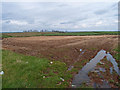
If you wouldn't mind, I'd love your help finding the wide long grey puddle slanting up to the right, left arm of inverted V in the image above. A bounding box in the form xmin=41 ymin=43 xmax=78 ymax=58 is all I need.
xmin=72 ymin=50 xmax=106 ymax=87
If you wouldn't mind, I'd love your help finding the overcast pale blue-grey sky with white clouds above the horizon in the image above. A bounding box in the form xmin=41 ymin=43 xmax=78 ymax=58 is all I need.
xmin=2 ymin=2 xmax=118 ymax=32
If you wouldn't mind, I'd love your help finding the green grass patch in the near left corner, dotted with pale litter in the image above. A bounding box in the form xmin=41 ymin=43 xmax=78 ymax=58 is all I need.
xmin=2 ymin=50 xmax=72 ymax=88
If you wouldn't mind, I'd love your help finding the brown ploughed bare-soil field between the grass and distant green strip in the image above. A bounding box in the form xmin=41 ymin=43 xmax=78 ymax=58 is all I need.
xmin=2 ymin=35 xmax=118 ymax=87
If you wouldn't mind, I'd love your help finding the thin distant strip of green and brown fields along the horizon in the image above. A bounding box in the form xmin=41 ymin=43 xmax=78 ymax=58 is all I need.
xmin=2 ymin=31 xmax=120 ymax=38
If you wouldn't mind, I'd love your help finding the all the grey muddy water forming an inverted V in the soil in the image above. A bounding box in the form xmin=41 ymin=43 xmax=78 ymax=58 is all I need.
xmin=72 ymin=50 xmax=120 ymax=88
